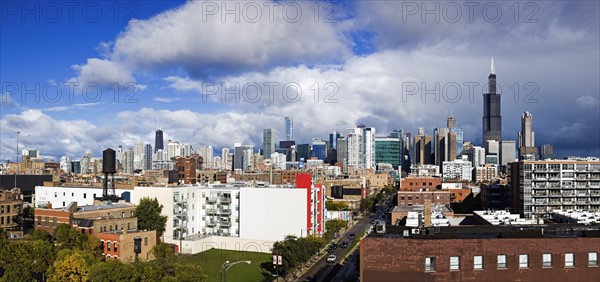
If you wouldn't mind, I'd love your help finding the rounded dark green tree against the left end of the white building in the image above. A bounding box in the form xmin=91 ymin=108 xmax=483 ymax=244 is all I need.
xmin=133 ymin=197 xmax=167 ymax=234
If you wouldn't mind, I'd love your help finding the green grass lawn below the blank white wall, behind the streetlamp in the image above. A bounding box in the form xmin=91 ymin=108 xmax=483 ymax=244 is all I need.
xmin=178 ymin=249 xmax=272 ymax=282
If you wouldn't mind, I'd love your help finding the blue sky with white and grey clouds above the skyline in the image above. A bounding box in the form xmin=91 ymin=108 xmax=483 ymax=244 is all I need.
xmin=0 ymin=1 xmax=600 ymax=160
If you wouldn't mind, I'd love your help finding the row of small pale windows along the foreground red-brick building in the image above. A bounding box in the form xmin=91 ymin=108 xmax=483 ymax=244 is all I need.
xmin=425 ymin=252 xmax=598 ymax=272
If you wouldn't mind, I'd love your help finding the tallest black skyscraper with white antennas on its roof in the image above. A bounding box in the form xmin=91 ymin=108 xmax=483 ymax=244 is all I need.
xmin=482 ymin=58 xmax=502 ymax=150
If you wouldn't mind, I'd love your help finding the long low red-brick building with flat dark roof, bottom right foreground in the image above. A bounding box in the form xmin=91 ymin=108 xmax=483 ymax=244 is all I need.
xmin=360 ymin=224 xmax=600 ymax=281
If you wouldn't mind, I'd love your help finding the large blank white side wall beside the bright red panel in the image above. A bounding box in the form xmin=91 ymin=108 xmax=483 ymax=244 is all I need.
xmin=240 ymin=188 xmax=308 ymax=241
